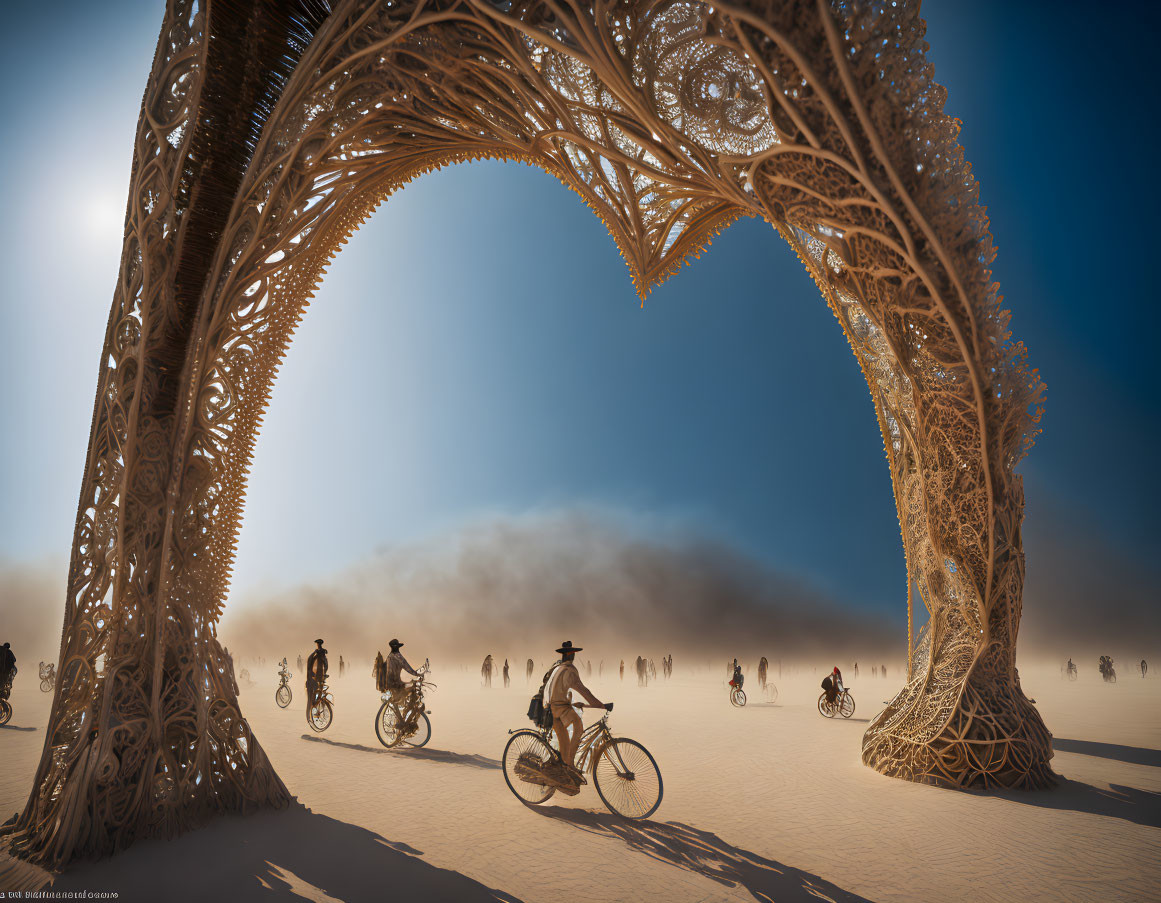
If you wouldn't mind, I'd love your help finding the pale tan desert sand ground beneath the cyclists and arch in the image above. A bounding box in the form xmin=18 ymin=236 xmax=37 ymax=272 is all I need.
xmin=0 ymin=656 xmax=1161 ymax=903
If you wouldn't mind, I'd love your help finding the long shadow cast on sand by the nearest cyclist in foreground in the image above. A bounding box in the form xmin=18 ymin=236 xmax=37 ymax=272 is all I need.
xmin=529 ymin=806 xmax=871 ymax=903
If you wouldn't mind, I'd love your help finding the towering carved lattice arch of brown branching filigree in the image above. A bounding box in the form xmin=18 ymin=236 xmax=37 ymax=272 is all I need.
xmin=7 ymin=0 xmax=1052 ymax=866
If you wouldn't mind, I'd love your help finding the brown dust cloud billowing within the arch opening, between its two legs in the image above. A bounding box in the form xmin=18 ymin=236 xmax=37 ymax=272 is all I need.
xmin=219 ymin=512 xmax=907 ymax=667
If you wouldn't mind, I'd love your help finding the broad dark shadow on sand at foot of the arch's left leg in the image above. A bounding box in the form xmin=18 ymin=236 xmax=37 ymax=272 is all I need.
xmin=37 ymin=803 xmax=519 ymax=903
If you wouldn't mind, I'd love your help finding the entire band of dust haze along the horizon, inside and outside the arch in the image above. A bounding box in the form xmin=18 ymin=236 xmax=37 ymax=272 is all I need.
xmin=0 ymin=510 xmax=1161 ymax=669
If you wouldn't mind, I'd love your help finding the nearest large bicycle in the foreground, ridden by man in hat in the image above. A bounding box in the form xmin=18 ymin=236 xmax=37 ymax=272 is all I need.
xmin=503 ymin=702 xmax=665 ymax=819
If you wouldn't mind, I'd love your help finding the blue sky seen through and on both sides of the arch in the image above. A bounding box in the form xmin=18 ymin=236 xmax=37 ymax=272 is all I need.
xmin=0 ymin=0 xmax=1161 ymax=620
